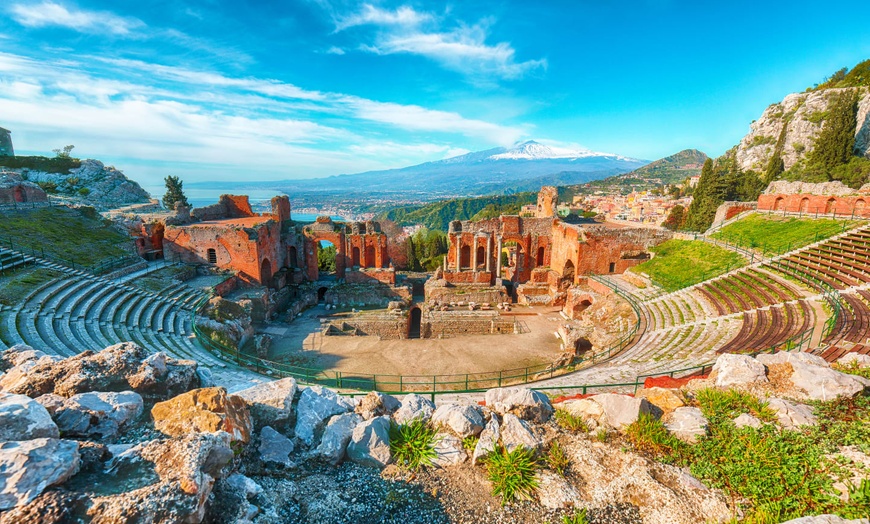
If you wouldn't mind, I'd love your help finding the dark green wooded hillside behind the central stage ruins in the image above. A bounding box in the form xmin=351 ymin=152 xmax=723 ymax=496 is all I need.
xmin=378 ymin=193 xmax=537 ymax=231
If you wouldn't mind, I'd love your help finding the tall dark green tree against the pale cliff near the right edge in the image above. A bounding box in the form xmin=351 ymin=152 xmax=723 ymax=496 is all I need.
xmin=808 ymin=90 xmax=858 ymax=173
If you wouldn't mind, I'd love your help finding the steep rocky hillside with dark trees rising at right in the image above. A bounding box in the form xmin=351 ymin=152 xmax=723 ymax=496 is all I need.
xmin=686 ymin=60 xmax=870 ymax=231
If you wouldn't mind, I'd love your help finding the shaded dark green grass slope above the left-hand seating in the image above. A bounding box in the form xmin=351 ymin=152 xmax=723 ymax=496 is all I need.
xmin=0 ymin=207 xmax=132 ymax=267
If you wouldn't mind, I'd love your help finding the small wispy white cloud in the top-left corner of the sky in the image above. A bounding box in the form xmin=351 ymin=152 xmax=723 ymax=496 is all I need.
xmin=9 ymin=0 xmax=145 ymax=36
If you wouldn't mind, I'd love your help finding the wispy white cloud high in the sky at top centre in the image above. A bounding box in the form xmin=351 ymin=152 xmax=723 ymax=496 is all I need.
xmin=335 ymin=4 xmax=547 ymax=79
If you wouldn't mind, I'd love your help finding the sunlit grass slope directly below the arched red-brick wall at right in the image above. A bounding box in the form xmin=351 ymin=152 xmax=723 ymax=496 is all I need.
xmin=711 ymin=214 xmax=861 ymax=255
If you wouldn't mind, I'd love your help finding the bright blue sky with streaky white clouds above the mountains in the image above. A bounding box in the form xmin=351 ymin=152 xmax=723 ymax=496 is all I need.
xmin=0 ymin=0 xmax=870 ymax=186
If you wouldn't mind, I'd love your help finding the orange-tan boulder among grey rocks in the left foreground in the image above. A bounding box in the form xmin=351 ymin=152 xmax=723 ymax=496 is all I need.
xmin=151 ymin=388 xmax=251 ymax=443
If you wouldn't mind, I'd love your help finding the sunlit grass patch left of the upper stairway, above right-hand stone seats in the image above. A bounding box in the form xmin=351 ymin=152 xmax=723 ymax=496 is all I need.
xmin=631 ymin=240 xmax=746 ymax=292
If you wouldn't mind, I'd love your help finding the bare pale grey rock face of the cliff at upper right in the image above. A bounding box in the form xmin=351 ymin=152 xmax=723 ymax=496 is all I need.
xmin=736 ymin=87 xmax=870 ymax=172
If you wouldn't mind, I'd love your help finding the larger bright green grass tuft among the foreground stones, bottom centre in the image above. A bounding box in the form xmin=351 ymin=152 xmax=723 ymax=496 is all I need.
xmin=486 ymin=446 xmax=538 ymax=504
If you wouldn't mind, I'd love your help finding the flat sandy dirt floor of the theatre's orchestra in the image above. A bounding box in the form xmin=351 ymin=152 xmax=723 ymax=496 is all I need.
xmin=262 ymin=306 xmax=562 ymax=375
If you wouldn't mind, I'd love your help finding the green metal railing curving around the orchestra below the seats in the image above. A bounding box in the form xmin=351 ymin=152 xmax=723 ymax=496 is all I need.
xmin=191 ymin=275 xmax=643 ymax=394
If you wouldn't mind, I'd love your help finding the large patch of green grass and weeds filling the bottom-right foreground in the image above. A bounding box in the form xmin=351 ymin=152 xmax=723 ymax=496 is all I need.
xmin=626 ymin=389 xmax=870 ymax=524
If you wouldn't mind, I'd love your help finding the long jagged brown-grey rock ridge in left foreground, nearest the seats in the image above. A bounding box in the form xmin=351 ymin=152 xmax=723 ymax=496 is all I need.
xmin=0 ymin=342 xmax=199 ymax=398
